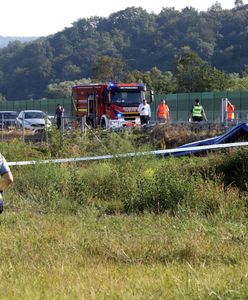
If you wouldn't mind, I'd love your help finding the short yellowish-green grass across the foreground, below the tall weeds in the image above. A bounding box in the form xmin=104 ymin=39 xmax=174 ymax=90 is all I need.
xmin=0 ymin=210 xmax=248 ymax=299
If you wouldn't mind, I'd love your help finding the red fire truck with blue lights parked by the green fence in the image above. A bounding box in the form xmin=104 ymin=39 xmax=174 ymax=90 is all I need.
xmin=72 ymin=82 xmax=153 ymax=128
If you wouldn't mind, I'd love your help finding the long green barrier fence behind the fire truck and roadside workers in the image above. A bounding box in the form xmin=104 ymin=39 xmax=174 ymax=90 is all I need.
xmin=0 ymin=91 xmax=248 ymax=122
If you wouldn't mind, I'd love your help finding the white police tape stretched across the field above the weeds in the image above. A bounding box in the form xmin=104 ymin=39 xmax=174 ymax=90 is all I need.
xmin=8 ymin=142 xmax=248 ymax=166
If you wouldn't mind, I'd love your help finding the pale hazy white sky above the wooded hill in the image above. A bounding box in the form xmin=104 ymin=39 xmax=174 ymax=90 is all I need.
xmin=0 ymin=0 xmax=243 ymax=36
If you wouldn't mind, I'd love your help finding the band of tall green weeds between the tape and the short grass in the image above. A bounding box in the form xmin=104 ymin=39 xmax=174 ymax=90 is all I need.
xmin=7 ymin=136 xmax=248 ymax=219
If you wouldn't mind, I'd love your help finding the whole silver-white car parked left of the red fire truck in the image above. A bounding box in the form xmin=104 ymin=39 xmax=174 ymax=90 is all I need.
xmin=16 ymin=110 xmax=51 ymax=131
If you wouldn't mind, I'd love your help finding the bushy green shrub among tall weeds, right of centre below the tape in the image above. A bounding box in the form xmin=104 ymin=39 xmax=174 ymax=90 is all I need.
xmin=124 ymin=158 xmax=192 ymax=213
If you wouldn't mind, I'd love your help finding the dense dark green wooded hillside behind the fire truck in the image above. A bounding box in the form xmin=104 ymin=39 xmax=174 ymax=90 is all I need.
xmin=0 ymin=1 xmax=248 ymax=100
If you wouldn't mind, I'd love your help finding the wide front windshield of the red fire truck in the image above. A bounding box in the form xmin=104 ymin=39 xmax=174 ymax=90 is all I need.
xmin=112 ymin=91 xmax=144 ymax=106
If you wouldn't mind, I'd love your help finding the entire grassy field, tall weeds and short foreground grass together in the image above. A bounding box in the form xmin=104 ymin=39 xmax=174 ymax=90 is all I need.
xmin=0 ymin=127 xmax=248 ymax=299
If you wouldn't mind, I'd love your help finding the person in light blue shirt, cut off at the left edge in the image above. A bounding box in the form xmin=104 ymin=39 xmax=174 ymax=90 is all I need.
xmin=0 ymin=153 xmax=13 ymax=214
